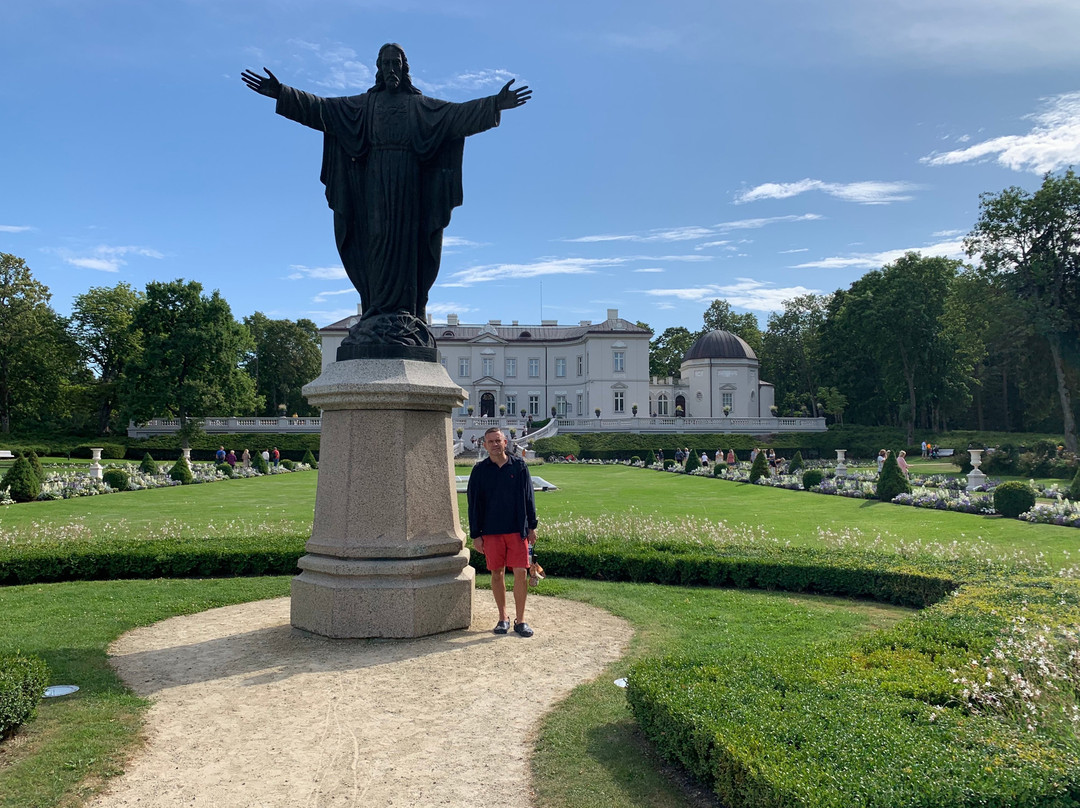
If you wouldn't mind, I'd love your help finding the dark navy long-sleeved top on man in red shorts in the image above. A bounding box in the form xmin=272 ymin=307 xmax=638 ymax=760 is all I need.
xmin=467 ymin=457 xmax=537 ymax=538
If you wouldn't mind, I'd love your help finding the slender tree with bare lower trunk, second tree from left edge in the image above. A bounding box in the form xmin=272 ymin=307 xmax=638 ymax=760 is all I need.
xmin=71 ymin=283 xmax=144 ymax=435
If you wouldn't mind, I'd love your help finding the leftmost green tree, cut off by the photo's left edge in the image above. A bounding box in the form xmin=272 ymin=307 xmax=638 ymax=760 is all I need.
xmin=0 ymin=253 xmax=78 ymax=434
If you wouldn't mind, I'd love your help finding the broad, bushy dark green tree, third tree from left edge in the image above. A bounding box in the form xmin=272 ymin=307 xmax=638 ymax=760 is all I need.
xmin=122 ymin=280 xmax=260 ymax=436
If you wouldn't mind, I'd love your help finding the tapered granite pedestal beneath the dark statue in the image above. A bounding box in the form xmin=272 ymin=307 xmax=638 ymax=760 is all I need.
xmin=292 ymin=359 xmax=475 ymax=637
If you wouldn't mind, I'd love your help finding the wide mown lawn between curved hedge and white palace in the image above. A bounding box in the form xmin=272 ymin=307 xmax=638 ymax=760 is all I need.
xmin=0 ymin=463 xmax=1080 ymax=567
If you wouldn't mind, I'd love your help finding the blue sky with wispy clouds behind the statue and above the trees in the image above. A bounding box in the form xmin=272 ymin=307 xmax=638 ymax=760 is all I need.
xmin=0 ymin=0 xmax=1080 ymax=333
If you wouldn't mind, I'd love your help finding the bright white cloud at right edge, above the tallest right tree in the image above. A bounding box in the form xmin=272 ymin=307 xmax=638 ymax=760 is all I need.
xmin=919 ymin=92 xmax=1080 ymax=174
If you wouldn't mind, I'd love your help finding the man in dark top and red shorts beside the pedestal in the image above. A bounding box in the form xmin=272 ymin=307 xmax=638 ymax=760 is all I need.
xmin=467 ymin=427 xmax=537 ymax=637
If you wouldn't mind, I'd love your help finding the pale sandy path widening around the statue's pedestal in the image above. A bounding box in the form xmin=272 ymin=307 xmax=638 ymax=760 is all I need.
xmin=91 ymin=592 xmax=631 ymax=808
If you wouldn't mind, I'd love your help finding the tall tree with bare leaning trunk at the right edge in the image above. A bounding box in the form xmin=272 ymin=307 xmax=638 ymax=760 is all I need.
xmin=964 ymin=170 xmax=1080 ymax=452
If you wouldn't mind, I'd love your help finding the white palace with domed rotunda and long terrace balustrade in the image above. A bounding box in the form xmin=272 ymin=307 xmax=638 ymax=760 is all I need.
xmin=129 ymin=309 xmax=825 ymax=443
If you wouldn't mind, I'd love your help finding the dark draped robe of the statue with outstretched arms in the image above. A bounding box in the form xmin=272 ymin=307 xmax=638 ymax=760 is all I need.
xmin=278 ymin=85 xmax=500 ymax=347
